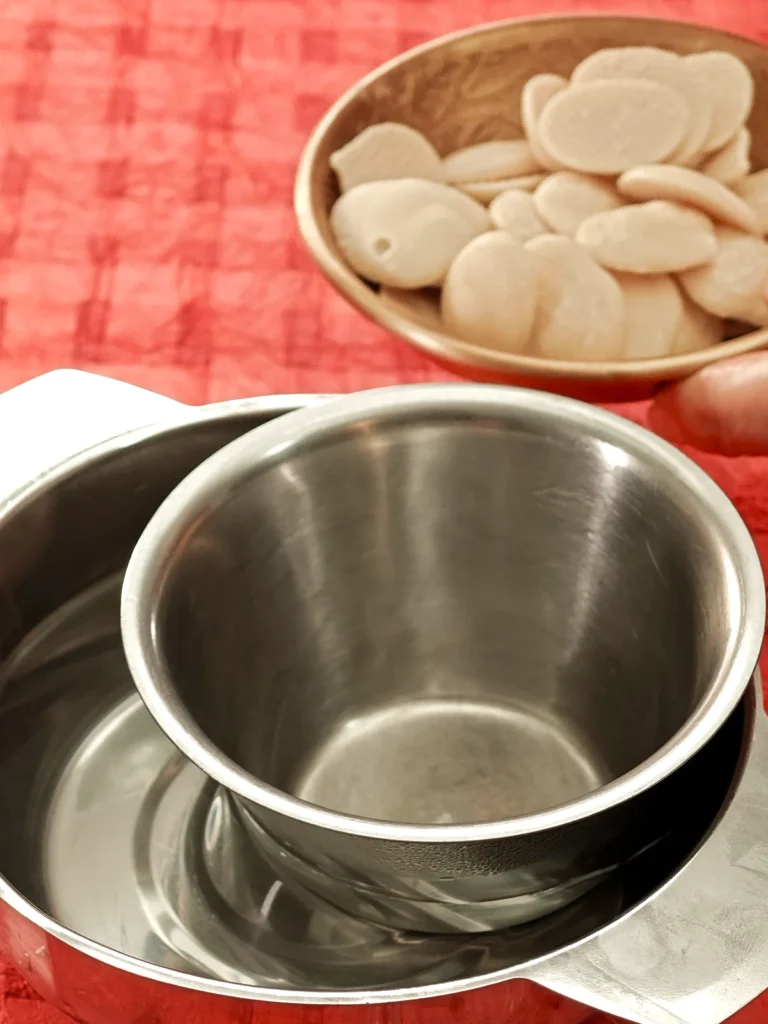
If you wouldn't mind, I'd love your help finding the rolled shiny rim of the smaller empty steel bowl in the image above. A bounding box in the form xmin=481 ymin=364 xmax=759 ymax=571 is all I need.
xmin=121 ymin=383 xmax=766 ymax=844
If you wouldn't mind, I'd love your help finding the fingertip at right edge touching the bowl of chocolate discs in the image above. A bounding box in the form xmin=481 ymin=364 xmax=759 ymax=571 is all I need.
xmin=649 ymin=352 xmax=768 ymax=455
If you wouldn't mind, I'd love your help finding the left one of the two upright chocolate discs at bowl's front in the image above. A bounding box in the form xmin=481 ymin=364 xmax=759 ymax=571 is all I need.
xmin=441 ymin=231 xmax=537 ymax=352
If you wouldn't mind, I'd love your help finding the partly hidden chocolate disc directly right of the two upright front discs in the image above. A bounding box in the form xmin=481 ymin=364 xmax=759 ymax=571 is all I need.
xmin=615 ymin=273 xmax=683 ymax=359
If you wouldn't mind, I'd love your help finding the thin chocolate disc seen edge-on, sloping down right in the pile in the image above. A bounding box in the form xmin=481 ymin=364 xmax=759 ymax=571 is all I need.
xmin=616 ymin=164 xmax=757 ymax=231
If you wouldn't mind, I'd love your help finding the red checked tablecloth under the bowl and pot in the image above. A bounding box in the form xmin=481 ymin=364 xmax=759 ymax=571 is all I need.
xmin=0 ymin=0 xmax=768 ymax=1024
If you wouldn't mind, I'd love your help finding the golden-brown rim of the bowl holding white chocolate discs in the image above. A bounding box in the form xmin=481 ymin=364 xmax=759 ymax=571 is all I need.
xmin=294 ymin=11 xmax=768 ymax=383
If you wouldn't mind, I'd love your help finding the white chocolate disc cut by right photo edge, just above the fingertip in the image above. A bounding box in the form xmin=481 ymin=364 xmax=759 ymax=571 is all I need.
xmin=680 ymin=227 xmax=768 ymax=327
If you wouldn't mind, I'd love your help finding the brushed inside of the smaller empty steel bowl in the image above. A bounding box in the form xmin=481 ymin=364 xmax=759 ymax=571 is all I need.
xmin=150 ymin=388 xmax=742 ymax=824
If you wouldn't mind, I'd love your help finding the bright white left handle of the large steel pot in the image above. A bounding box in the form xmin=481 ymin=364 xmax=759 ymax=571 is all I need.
xmin=0 ymin=370 xmax=188 ymax=496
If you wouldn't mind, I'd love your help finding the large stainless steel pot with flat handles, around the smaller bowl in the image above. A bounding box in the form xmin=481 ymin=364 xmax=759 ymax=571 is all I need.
xmin=0 ymin=372 xmax=768 ymax=1024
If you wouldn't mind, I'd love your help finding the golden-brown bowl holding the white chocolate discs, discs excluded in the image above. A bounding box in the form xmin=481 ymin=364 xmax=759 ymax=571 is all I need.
xmin=295 ymin=15 xmax=768 ymax=400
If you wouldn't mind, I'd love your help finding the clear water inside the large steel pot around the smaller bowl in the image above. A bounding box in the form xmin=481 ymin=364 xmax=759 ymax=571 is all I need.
xmin=0 ymin=573 xmax=696 ymax=992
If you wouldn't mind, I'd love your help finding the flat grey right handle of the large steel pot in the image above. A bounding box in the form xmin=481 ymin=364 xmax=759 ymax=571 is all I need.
xmin=526 ymin=701 xmax=768 ymax=1024
